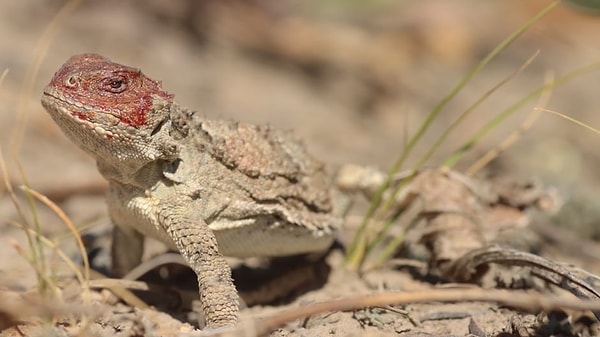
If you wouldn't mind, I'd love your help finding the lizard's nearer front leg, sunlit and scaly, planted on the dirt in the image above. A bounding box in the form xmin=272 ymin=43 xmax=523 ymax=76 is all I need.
xmin=158 ymin=202 xmax=239 ymax=328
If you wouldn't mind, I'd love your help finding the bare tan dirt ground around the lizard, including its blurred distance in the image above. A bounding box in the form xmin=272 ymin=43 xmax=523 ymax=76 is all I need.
xmin=0 ymin=0 xmax=600 ymax=336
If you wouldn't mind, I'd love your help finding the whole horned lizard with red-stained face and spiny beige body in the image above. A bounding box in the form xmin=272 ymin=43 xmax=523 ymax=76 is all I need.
xmin=42 ymin=54 xmax=341 ymax=328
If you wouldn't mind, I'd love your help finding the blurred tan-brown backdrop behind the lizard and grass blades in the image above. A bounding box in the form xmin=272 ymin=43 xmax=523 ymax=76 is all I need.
xmin=0 ymin=0 xmax=600 ymax=284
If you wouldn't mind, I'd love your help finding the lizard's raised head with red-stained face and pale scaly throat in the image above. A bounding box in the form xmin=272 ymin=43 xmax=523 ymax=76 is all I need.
xmin=42 ymin=54 xmax=176 ymax=176
